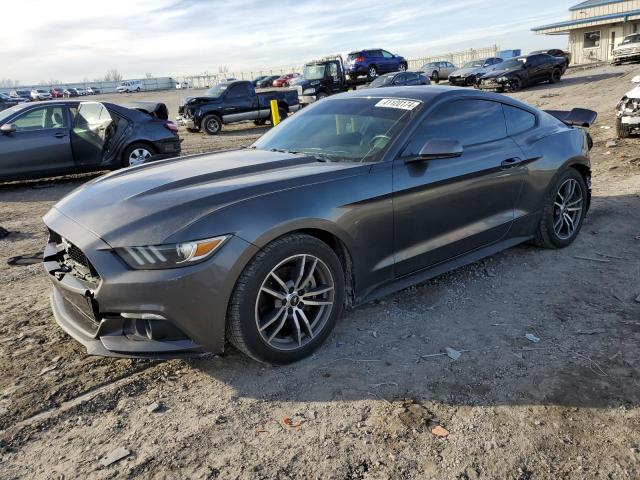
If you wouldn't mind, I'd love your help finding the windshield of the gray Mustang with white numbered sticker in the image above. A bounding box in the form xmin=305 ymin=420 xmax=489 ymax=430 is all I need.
xmin=252 ymin=97 xmax=422 ymax=162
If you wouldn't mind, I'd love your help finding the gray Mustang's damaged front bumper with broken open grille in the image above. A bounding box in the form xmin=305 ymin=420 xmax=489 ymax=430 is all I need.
xmin=44 ymin=209 xmax=257 ymax=358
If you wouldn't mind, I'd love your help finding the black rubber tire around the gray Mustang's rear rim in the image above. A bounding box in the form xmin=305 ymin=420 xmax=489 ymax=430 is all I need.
xmin=533 ymin=168 xmax=588 ymax=248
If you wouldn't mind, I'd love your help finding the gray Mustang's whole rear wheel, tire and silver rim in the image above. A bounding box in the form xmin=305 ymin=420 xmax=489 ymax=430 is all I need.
xmin=535 ymin=168 xmax=588 ymax=248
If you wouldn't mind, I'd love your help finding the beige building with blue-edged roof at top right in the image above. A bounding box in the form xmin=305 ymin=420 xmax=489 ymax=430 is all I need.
xmin=532 ymin=0 xmax=640 ymax=65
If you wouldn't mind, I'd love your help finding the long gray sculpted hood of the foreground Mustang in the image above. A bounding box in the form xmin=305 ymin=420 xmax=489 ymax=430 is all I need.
xmin=45 ymin=149 xmax=362 ymax=248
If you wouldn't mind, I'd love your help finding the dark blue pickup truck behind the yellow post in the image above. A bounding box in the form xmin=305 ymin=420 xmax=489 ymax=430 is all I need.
xmin=177 ymin=80 xmax=300 ymax=135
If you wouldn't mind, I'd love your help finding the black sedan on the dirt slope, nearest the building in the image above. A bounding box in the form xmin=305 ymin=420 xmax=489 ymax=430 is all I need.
xmin=477 ymin=54 xmax=564 ymax=92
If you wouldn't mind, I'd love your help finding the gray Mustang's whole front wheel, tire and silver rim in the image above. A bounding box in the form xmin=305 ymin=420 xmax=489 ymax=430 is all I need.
xmin=227 ymin=234 xmax=345 ymax=364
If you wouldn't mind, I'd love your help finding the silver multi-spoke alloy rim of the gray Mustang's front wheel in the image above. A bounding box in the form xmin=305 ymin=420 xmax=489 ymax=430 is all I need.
xmin=255 ymin=254 xmax=335 ymax=351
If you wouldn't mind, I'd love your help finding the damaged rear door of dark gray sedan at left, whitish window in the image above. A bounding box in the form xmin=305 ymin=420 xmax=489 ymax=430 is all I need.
xmin=71 ymin=102 xmax=113 ymax=167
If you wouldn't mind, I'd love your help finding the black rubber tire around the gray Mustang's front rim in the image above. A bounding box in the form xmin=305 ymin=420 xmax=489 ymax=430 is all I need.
xmin=227 ymin=233 xmax=345 ymax=365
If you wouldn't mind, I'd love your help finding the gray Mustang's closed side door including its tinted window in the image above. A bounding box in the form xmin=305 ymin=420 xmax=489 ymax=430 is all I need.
xmin=393 ymin=99 xmax=527 ymax=276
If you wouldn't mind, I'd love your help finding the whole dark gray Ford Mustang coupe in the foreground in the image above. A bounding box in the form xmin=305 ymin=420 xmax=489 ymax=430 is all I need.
xmin=44 ymin=86 xmax=595 ymax=364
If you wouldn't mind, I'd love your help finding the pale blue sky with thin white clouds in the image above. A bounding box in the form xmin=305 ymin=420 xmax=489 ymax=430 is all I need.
xmin=0 ymin=0 xmax=578 ymax=83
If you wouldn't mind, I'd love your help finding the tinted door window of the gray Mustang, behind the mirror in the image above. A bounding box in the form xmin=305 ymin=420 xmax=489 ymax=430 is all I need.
xmin=409 ymin=100 xmax=507 ymax=153
